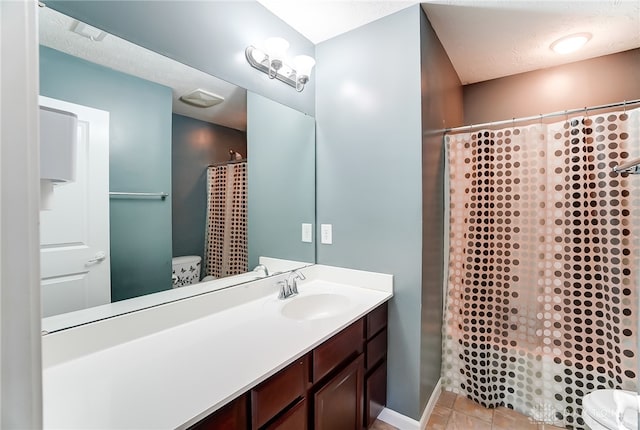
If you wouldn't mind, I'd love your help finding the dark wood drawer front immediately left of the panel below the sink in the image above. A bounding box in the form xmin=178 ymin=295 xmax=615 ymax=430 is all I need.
xmin=251 ymin=355 xmax=309 ymax=429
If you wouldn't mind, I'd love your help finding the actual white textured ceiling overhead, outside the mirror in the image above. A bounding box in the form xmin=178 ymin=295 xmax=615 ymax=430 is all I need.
xmin=259 ymin=0 xmax=640 ymax=84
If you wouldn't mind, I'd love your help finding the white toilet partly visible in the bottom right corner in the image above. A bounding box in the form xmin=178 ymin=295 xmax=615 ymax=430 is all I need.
xmin=582 ymin=390 xmax=640 ymax=430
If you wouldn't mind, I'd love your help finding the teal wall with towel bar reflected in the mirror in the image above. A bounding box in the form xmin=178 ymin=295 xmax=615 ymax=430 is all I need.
xmin=40 ymin=47 xmax=171 ymax=301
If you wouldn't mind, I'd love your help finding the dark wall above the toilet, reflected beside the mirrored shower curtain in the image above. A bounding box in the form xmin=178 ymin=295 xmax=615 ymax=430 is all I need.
xmin=171 ymin=114 xmax=247 ymax=261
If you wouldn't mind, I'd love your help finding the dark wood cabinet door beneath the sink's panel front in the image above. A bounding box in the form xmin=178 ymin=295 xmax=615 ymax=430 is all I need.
xmin=313 ymin=354 xmax=364 ymax=430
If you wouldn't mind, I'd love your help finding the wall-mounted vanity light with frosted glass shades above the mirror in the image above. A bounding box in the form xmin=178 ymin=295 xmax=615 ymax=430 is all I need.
xmin=245 ymin=37 xmax=316 ymax=92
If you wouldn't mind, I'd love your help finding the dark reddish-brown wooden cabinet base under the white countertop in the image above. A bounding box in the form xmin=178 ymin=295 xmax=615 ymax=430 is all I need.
xmin=191 ymin=303 xmax=387 ymax=430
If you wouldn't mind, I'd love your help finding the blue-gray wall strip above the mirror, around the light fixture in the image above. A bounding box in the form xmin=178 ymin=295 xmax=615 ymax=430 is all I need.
xmin=46 ymin=0 xmax=316 ymax=115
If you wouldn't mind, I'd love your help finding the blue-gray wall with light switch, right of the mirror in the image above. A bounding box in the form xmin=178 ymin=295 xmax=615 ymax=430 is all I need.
xmin=316 ymin=4 xmax=422 ymax=418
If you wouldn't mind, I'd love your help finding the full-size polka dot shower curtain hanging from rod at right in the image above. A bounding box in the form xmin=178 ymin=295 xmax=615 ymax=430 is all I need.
xmin=442 ymin=109 xmax=640 ymax=429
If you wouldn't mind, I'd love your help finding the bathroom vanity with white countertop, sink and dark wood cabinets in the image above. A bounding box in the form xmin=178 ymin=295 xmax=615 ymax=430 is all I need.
xmin=43 ymin=265 xmax=393 ymax=430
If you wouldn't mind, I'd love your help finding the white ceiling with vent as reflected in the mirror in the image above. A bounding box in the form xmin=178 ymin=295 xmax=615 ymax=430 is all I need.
xmin=38 ymin=6 xmax=247 ymax=130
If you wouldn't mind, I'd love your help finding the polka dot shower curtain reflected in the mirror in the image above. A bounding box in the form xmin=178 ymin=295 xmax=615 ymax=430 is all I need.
xmin=205 ymin=161 xmax=248 ymax=278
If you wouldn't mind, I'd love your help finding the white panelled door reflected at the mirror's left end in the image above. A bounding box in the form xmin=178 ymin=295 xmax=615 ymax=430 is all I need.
xmin=40 ymin=97 xmax=111 ymax=317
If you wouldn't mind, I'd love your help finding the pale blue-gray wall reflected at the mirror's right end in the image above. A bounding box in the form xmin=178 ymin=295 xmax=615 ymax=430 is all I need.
xmin=247 ymin=92 xmax=316 ymax=268
